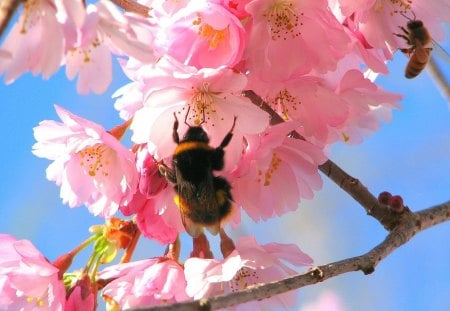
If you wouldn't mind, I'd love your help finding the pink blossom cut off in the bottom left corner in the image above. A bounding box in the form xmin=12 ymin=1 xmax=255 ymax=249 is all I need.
xmin=0 ymin=234 xmax=66 ymax=311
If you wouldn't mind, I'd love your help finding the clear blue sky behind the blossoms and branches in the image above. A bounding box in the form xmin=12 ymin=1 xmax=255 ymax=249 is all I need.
xmin=0 ymin=22 xmax=450 ymax=311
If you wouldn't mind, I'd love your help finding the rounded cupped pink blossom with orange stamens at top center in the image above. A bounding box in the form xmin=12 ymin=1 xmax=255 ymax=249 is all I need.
xmin=155 ymin=0 xmax=245 ymax=69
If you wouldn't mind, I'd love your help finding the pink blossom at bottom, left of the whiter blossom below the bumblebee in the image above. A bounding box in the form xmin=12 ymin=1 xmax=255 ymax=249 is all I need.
xmin=98 ymin=258 xmax=189 ymax=310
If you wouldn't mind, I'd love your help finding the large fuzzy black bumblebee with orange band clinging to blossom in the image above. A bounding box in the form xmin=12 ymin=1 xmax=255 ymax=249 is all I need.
xmin=159 ymin=113 xmax=236 ymax=237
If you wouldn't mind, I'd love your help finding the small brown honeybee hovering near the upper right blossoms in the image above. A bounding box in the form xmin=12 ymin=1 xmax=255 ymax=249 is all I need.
xmin=395 ymin=19 xmax=432 ymax=79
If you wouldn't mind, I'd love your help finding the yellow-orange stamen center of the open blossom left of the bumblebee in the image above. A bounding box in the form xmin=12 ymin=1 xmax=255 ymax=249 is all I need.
xmin=78 ymin=144 xmax=110 ymax=177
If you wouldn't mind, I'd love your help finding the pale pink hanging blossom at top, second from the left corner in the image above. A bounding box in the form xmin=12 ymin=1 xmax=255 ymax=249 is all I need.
xmin=62 ymin=1 xmax=153 ymax=94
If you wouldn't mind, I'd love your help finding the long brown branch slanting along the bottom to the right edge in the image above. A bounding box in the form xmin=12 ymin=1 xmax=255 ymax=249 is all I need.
xmin=125 ymin=201 xmax=450 ymax=311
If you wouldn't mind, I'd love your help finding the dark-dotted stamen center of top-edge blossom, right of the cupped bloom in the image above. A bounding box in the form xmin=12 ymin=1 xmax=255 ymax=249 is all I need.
xmin=263 ymin=0 xmax=303 ymax=41
